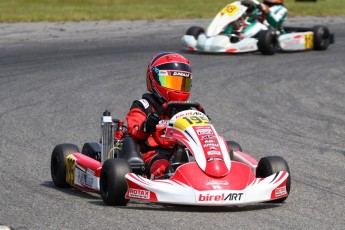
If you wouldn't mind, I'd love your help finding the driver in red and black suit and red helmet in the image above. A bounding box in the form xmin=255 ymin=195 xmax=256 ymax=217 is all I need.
xmin=126 ymin=52 xmax=200 ymax=180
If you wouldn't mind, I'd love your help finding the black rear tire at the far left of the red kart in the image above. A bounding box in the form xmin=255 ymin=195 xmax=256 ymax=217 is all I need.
xmin=50 ymin=143 xmax=79 ymax=188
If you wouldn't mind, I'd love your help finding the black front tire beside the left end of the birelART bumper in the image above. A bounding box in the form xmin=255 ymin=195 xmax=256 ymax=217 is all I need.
xmin=100 ymin=158 xmax=131 ymax=206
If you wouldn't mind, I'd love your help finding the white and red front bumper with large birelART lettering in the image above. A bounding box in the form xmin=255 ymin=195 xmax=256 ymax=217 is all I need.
xmin=126 ymin=163 xmax=289 ymax=206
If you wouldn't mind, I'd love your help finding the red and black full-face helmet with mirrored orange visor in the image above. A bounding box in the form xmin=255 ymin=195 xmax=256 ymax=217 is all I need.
xmin=146 ymin=52 xmax=192 ymax=101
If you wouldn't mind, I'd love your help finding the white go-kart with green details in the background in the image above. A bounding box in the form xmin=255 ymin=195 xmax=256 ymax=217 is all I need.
xmin=182 ymin=0 xmax=334 ymax=55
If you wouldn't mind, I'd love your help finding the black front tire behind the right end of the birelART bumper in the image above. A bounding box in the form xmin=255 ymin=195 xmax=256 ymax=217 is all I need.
xmin=256 ymin=156 xmax=291 ymax=203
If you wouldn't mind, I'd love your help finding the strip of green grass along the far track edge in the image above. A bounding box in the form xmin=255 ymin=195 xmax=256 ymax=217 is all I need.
xmin=0 ymin=0 xmax=345 ymax=22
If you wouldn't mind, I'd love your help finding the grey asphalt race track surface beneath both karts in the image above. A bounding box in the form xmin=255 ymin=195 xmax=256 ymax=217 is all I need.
xmin=0 ymin=17 xmax=345 ymax=229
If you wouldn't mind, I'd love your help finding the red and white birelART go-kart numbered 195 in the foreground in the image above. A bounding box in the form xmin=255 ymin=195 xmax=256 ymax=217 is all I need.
xmin=51 ymin=102 xmax=291 ymax=206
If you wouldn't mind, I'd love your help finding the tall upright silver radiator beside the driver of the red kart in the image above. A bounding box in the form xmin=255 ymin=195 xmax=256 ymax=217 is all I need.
xmin=101 ymin=110 xmax=114 ymax=163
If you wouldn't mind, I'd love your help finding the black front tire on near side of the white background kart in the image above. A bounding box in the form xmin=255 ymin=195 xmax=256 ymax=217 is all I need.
xmin=258 ymin=30 xmax=278 ymax=55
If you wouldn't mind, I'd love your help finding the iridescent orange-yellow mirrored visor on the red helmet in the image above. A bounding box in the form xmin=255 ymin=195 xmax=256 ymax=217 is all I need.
xmin=154 ymin=70 xmax=192 ymax=92
